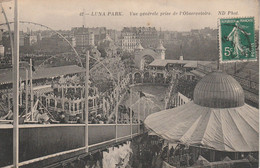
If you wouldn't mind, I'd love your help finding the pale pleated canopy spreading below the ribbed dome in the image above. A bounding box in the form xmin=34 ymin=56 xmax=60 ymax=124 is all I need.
xmin=144 ymin=101 xmax=259 ymax=152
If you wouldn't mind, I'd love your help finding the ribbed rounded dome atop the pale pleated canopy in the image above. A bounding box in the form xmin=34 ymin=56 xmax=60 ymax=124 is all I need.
xmin=193 ymin=71 xmax=245 ymax=108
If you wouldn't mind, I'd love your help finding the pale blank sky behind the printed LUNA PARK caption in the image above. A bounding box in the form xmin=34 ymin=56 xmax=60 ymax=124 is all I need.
xmin=0 ymin=0 xmax=259 ymax=31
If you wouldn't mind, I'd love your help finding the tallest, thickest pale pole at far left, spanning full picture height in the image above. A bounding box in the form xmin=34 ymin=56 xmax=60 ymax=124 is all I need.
xmin=13 ymin=0 xmax=19 ymax=168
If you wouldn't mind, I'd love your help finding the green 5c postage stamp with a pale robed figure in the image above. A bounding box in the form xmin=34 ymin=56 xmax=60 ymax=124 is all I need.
xmin=219 ymin=17 xmax=257 ymax=63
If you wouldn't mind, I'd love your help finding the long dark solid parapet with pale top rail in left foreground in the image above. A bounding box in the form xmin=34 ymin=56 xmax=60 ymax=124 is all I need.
xmin=0 ymin=124 xmax=142 ymax=167
